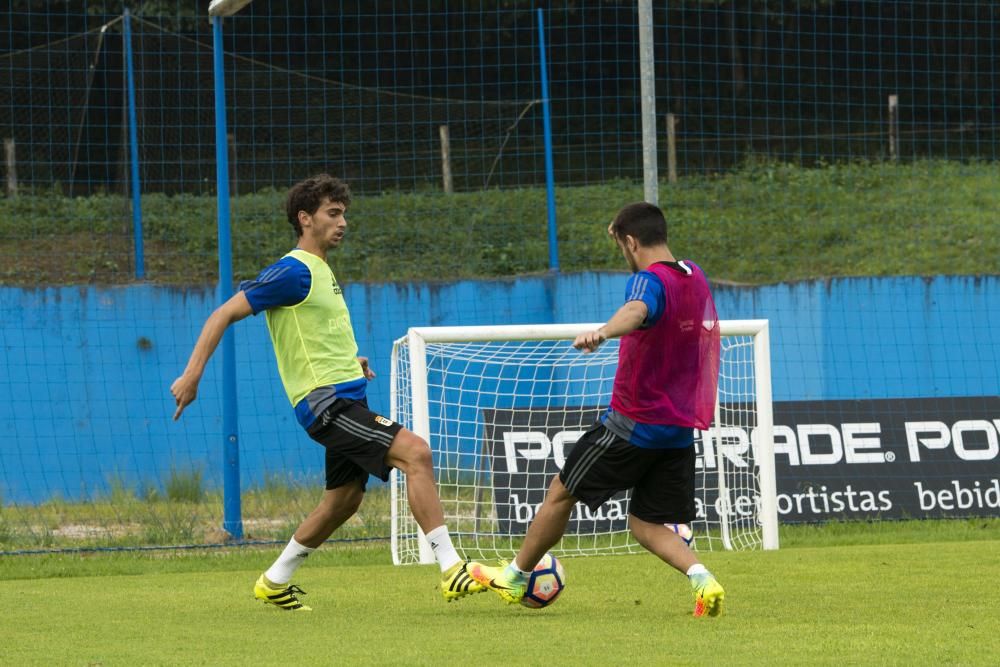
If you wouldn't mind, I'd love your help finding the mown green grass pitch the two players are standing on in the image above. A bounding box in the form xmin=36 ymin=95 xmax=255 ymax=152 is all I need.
xmin=0 ymin=520 xmax=1000 ymax=665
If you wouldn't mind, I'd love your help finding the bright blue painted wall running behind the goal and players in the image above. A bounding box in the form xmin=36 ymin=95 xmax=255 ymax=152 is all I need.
xmin=0 ymin=273 xmax=1000 ymax=502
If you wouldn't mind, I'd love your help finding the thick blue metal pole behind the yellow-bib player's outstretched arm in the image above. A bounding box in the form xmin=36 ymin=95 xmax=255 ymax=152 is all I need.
xmin=211 ymin=16 xmax=243 ymax=540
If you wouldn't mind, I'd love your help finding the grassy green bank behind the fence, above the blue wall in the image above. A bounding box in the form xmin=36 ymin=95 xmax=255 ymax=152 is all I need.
xmin=0 ymin=162 xmax=1000 ymax=286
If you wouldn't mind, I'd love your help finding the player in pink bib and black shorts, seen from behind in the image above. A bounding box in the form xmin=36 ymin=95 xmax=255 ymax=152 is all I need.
xmin=468 ymin=202 xmax=725 ymax=616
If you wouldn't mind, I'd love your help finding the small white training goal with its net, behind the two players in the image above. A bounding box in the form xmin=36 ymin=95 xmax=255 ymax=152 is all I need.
xmin=390 ymin=320 xmax=778 ymax=564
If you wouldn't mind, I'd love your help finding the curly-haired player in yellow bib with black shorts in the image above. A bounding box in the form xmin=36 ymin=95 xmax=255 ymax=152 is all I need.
xmin=170 ymin=174 xmax=485 ymax=611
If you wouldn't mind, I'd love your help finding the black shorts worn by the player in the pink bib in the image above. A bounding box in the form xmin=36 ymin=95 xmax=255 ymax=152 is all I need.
xmin=559 ymin=422 xmax=695 ymax=523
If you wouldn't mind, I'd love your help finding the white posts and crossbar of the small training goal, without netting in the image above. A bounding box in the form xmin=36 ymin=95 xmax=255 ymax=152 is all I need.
xmin=390 ymin=319 xmax=779 ymax=565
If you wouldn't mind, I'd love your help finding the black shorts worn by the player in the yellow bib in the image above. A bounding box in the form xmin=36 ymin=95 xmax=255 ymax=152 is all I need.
xmin=306 ymin=398 xmax=403 ymax=491
